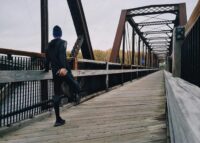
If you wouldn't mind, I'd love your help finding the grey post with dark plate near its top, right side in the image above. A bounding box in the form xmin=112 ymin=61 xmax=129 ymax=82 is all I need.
xmin=172 ymin=26 xmax=185 ymax=77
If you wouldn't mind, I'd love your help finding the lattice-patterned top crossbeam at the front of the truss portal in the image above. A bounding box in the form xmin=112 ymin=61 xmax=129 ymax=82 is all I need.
xmin=128 ymin=4 xmax=178 ymax=17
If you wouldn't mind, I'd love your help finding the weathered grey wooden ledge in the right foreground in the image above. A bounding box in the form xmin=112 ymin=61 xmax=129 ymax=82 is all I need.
xmin=165 ymin=72 xmax=200 ymax=143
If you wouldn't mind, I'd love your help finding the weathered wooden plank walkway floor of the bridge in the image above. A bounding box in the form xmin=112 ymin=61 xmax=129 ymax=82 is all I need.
xmin=0 ymin=71 xmax=166 ymax=143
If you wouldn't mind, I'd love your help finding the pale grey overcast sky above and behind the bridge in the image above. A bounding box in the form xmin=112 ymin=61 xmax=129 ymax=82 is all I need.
xmin=0 ymin=0 xmax=198 ymax=52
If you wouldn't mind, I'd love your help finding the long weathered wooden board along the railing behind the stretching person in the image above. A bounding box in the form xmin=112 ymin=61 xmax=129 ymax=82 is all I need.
xmin=0 ymin=69 xmax=157 ymax=83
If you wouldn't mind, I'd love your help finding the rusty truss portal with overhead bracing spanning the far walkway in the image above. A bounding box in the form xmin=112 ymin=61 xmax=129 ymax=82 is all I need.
xmin=110 ymin=3 xmax=187 ymax=67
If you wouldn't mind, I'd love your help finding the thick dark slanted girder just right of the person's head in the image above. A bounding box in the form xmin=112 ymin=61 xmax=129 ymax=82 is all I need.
xmin=67 ymin=0 xmax=94 ymax=60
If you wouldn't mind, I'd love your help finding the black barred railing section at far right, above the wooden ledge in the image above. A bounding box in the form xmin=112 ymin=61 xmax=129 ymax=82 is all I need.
xmin=181 ymin=17 xmax=200 ymax=86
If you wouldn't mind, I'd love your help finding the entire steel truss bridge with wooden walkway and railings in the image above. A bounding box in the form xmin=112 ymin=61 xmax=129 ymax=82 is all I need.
xmin=0 ymin=0 xmax=200 ymax=143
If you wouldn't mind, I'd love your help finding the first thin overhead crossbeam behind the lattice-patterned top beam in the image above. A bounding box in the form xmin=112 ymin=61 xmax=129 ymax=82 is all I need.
xmin=137 ymin=20 xmax=175 ymax=26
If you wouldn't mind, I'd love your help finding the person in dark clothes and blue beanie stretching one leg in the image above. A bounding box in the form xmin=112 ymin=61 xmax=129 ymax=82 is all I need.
xmin=45 ymin=25 xmax=80 ymax=126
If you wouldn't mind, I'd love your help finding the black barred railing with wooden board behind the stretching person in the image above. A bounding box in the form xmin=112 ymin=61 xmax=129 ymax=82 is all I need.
xmin=0 ymin=52 xmax=157 ymax=127
